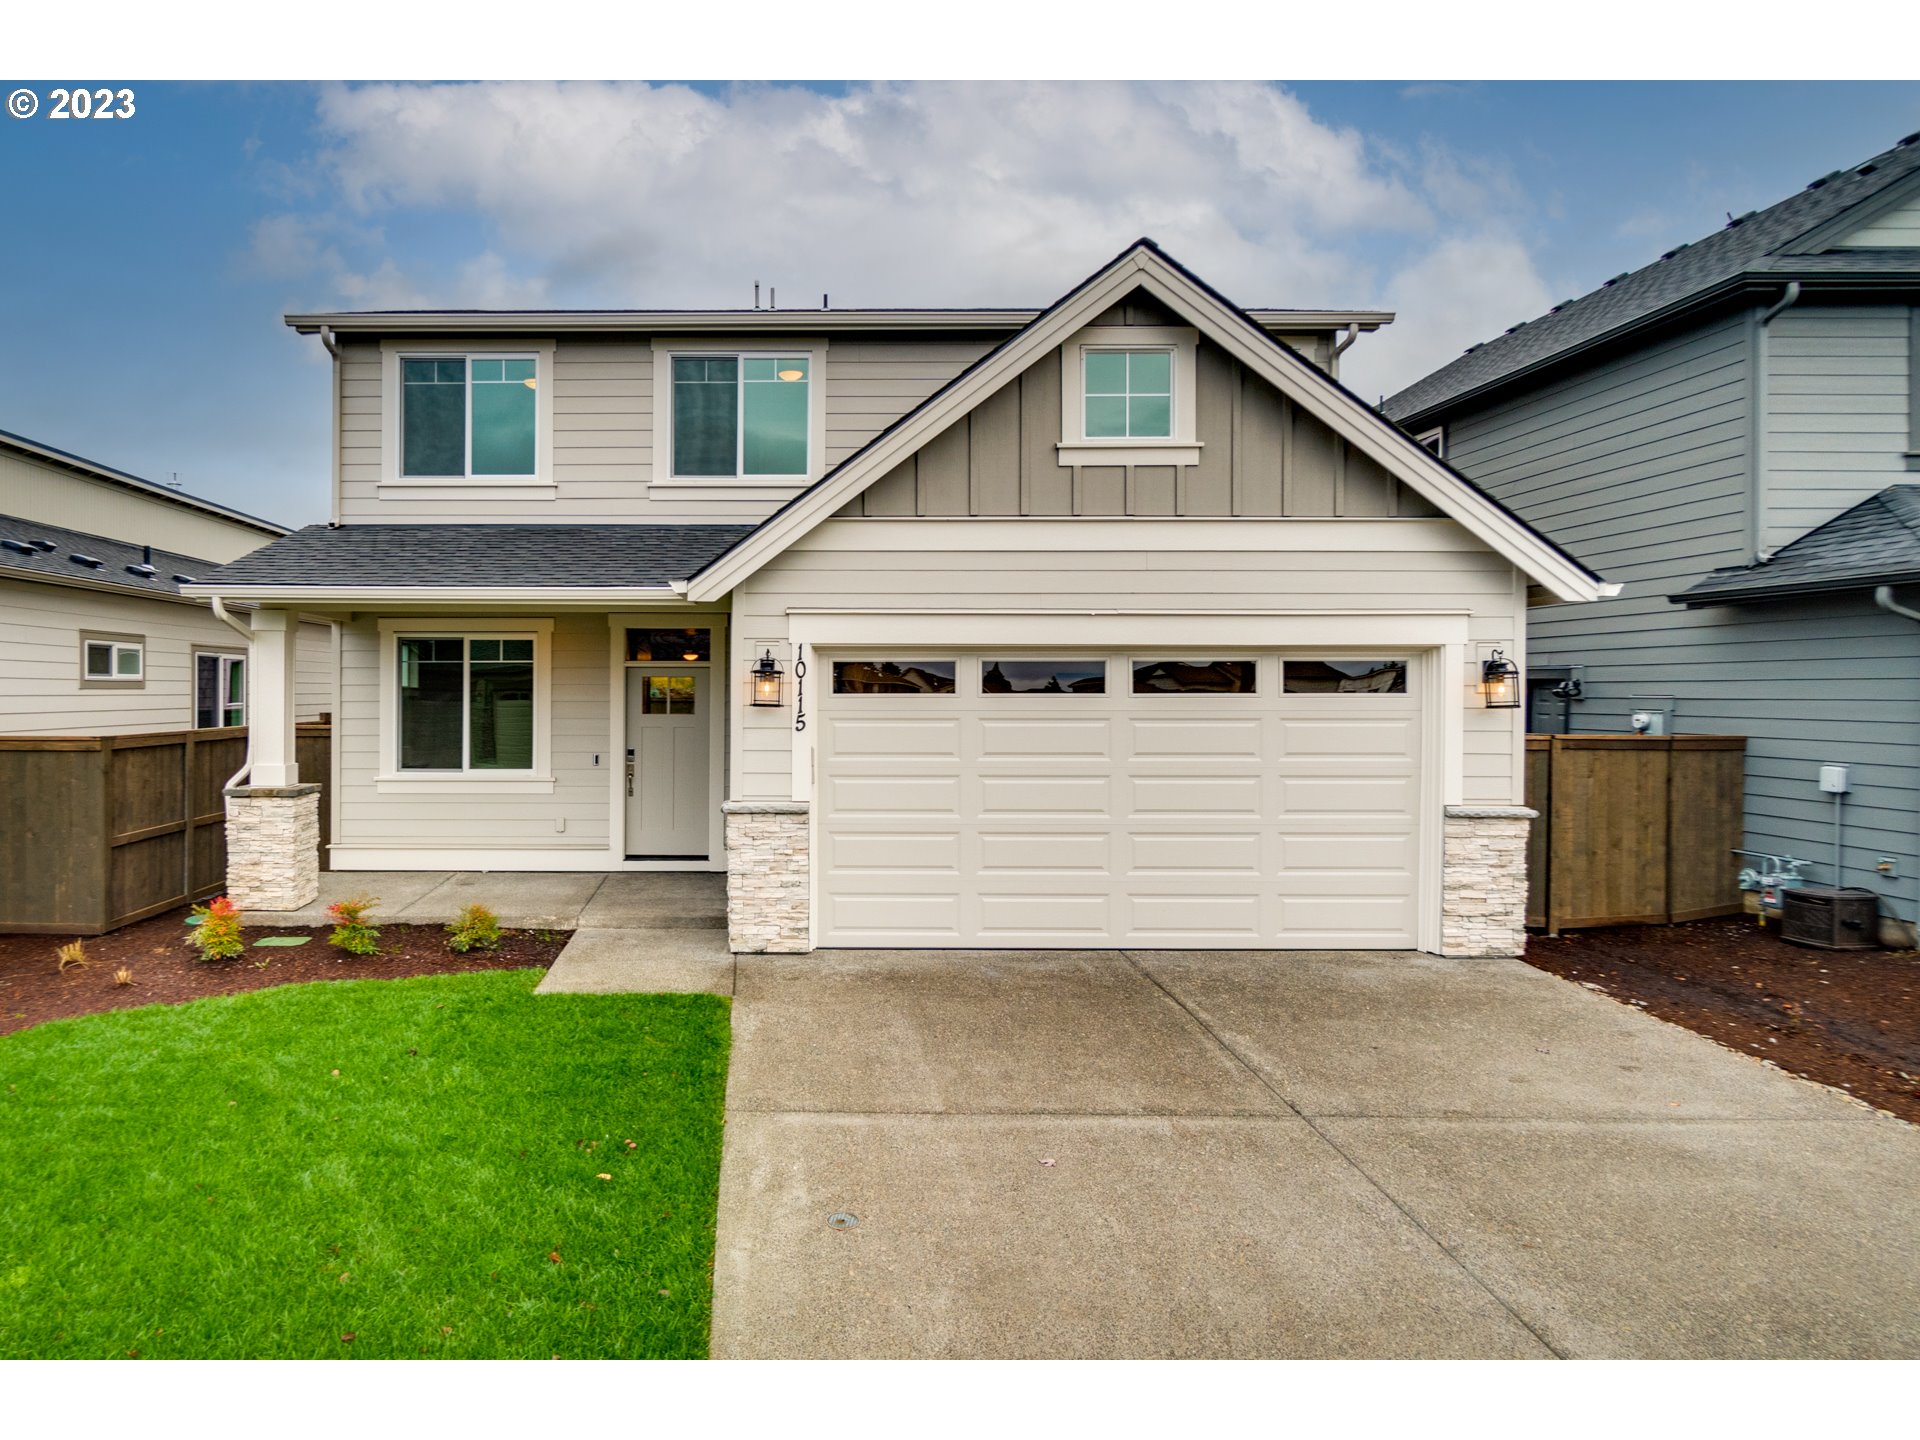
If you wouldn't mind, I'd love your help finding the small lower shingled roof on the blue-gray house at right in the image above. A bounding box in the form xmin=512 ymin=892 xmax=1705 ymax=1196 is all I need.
xmin=1670 ymin=486 xmax=1920 ymax=605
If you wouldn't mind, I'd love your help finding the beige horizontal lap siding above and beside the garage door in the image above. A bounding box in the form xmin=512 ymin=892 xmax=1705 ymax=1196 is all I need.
xmin=730 ymin=520 xmax=1524 ymax=804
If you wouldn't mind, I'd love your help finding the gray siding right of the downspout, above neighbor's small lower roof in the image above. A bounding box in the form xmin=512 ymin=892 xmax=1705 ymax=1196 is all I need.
xmin=1761 ymin=305 xmax=1912 ymax=551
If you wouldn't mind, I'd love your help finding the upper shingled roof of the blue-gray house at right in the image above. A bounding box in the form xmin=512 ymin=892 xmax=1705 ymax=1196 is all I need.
xmin=1380 ymin=134 xmax=1920 ymax=422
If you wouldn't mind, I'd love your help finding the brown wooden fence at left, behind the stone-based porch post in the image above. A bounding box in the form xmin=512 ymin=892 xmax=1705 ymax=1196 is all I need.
xmin=0 ymin=726 xmax=332 ymax=935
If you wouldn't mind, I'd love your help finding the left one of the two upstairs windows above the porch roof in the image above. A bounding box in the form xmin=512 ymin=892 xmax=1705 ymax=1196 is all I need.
xmin=399 ymin=355 xmax=540 ymax=478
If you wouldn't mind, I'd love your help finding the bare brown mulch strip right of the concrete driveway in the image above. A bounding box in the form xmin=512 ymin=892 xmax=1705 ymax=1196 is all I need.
xmin=1526 ymin=916 xmax=1920 ymax=1123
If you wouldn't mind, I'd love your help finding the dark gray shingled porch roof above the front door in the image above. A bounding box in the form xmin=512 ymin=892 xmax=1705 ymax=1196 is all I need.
xmin=202 ymin=524 xmax=753 ymax=591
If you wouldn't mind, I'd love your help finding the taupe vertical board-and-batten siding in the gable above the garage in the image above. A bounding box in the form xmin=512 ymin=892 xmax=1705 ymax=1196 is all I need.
xmin=841 ymin=337 xmax=1434 ymax=518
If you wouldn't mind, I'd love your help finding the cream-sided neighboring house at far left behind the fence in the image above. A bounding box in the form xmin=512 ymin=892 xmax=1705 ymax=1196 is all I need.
xmin=0 ymin=432 xmax=334 ymax=735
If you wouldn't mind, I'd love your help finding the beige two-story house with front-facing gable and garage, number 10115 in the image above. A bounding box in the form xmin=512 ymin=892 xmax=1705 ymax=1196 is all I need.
xmin=190 ymin=240 xmax=1605 ymax=954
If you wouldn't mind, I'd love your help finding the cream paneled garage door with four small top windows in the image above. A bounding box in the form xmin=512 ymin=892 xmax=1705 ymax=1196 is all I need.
xmin=816 ymin=649 xmax=1423 ymax=948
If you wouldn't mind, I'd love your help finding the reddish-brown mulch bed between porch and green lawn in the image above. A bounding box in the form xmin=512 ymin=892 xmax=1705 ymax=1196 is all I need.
xmin=0 ymin=908 xmax=566 ymax=1035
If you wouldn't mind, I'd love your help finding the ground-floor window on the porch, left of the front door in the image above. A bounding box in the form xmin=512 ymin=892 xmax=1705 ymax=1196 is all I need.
xmin=394 ymin=632 xmax=538 ymax=774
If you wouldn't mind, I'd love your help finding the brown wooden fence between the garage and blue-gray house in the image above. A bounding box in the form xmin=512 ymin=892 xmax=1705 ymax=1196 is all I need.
xmin=1526 ymin=735 xmax=1747 ymax=935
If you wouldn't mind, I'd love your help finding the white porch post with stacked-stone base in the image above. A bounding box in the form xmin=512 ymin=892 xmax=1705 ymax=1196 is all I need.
xmin=227 ymin=611 xmax=321 ymax=910
